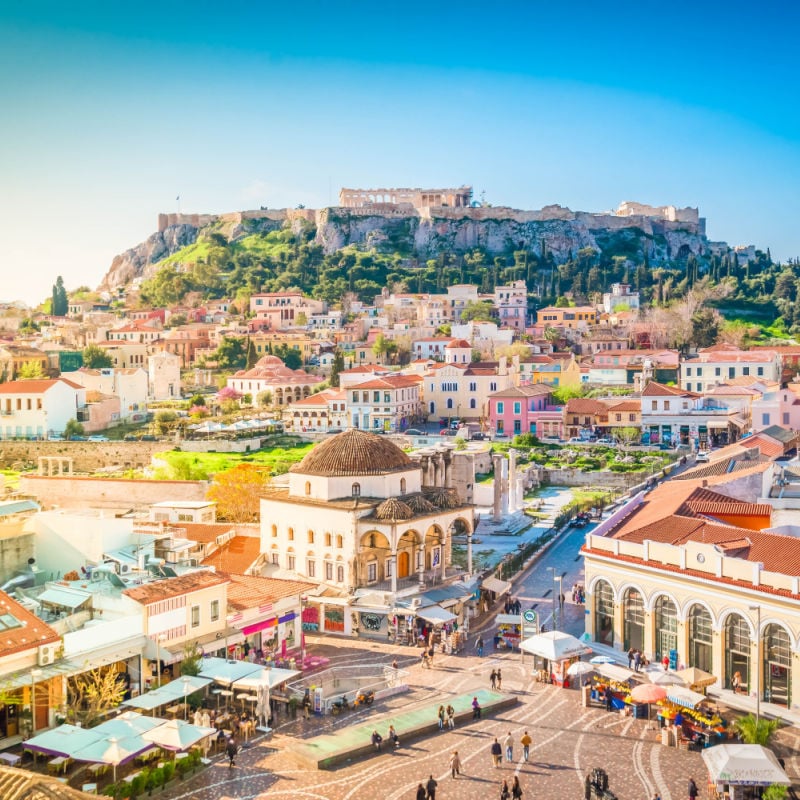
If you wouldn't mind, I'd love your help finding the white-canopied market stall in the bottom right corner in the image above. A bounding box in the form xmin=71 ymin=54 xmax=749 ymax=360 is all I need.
xmin=703 ymin=744 xmax=791 ymax=800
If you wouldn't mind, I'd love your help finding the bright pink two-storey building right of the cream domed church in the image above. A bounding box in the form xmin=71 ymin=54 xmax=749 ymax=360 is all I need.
xmin=489 ymin=383 xmax=563 ymax=438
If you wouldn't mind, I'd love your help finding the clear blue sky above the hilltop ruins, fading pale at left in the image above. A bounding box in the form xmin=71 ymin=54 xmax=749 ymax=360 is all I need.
xmin=0 ymin=0 xmax=800 ymax=304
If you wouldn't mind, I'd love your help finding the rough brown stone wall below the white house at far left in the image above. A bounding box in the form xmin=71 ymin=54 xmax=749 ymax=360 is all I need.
xmin=0 ymin=441 xmax=164 ymax=472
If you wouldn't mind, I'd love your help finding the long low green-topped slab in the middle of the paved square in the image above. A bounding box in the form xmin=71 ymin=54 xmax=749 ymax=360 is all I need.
xmin=292 ymin=689 xmax=518 ymax=769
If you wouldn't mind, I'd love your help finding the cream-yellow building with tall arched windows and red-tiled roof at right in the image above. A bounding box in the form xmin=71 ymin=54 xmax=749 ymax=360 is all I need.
xmin=583 ymin=463 xmax=800 ymax=708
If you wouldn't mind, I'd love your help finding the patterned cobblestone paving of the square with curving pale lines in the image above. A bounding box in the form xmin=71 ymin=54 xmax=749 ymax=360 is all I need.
xmin=159 ymin=637 xmax=705 ymax=800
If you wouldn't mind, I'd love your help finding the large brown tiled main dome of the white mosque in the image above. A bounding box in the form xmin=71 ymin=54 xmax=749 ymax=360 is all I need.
xmin=292 ymin=428 xmax=415 ymax=478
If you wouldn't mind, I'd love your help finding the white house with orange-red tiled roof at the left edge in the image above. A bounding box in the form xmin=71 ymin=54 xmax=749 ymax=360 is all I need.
xmin=0 ymin=378 xmax=89 ymax=439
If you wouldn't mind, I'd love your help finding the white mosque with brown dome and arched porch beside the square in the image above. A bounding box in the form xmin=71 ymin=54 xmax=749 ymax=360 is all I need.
xmin=261 ymin=428 xmax=474 ymax=641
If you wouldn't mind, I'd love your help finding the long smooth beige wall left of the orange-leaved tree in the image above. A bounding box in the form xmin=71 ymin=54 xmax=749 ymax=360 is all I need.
xmin=19 ymin=474 xmax=210 ymax=509
